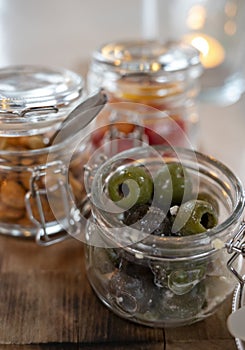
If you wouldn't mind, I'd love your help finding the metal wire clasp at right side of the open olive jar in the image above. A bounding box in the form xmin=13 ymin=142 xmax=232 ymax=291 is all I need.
xmin=226 ymin=221 xmax=245 ymax=289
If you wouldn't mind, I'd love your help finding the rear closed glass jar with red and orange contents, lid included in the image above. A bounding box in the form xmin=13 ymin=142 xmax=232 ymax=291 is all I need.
xmin=87 ymin=41 xmax=202 ymax=148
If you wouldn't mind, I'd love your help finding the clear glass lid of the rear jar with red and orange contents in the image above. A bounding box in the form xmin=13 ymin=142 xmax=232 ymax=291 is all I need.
xmin=93 ymin=40 xmax=202 ymax=78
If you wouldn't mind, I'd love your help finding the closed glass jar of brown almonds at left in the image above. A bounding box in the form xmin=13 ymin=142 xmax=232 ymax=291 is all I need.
xmin=0 ymin=66 xmax=89 ymax=244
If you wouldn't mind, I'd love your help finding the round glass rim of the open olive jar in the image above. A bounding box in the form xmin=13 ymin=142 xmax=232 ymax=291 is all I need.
xmin=91 ymin=146 xmax=245 ymax=258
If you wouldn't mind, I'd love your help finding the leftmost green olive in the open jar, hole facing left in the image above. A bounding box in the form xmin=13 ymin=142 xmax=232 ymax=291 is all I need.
xmin=108 ymin=166 xmax=153 ymax=209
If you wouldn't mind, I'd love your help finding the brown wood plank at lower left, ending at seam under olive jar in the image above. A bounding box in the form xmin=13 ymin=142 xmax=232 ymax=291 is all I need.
xmin=0 ymin=237 xmax=166 ymax=344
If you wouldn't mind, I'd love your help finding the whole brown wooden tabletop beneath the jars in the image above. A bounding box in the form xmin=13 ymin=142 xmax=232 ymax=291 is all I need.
xmin=0 ymin=232 xmax=236 ymax=350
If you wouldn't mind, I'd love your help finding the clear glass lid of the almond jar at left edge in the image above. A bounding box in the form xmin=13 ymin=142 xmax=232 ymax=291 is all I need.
xmin=0 ymin=65 xmax=84 ymax=135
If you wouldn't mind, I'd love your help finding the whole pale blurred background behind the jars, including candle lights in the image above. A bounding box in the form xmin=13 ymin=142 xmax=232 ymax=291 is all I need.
xmin=0 ymin=0 xmax=245 ymax=182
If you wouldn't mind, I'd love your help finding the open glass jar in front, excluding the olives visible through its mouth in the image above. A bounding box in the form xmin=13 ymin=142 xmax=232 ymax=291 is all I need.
xmin=85 ymin=146 xmax=244 ymax=327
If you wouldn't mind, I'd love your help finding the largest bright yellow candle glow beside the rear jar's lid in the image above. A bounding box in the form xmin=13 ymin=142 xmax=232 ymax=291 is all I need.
xmin=184 ymin=33 xmax=225 ymax=68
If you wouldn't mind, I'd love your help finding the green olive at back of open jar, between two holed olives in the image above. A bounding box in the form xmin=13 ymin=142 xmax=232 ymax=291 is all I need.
xmin=154 ymin=162 xmax=192 ymax=207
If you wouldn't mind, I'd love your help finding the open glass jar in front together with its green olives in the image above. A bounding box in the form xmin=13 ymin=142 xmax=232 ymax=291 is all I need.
xmin=85 ymin=145 xmax=244 ymax=327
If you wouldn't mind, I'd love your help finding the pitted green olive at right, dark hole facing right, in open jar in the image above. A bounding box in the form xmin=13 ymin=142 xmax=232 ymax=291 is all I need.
xmin=172 ymin=199 xmax=218 ymax=236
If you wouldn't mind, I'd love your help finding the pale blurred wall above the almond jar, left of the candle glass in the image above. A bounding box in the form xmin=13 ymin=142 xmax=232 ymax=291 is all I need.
xmin=0 ymin=0 xmax=141 ymax=73
